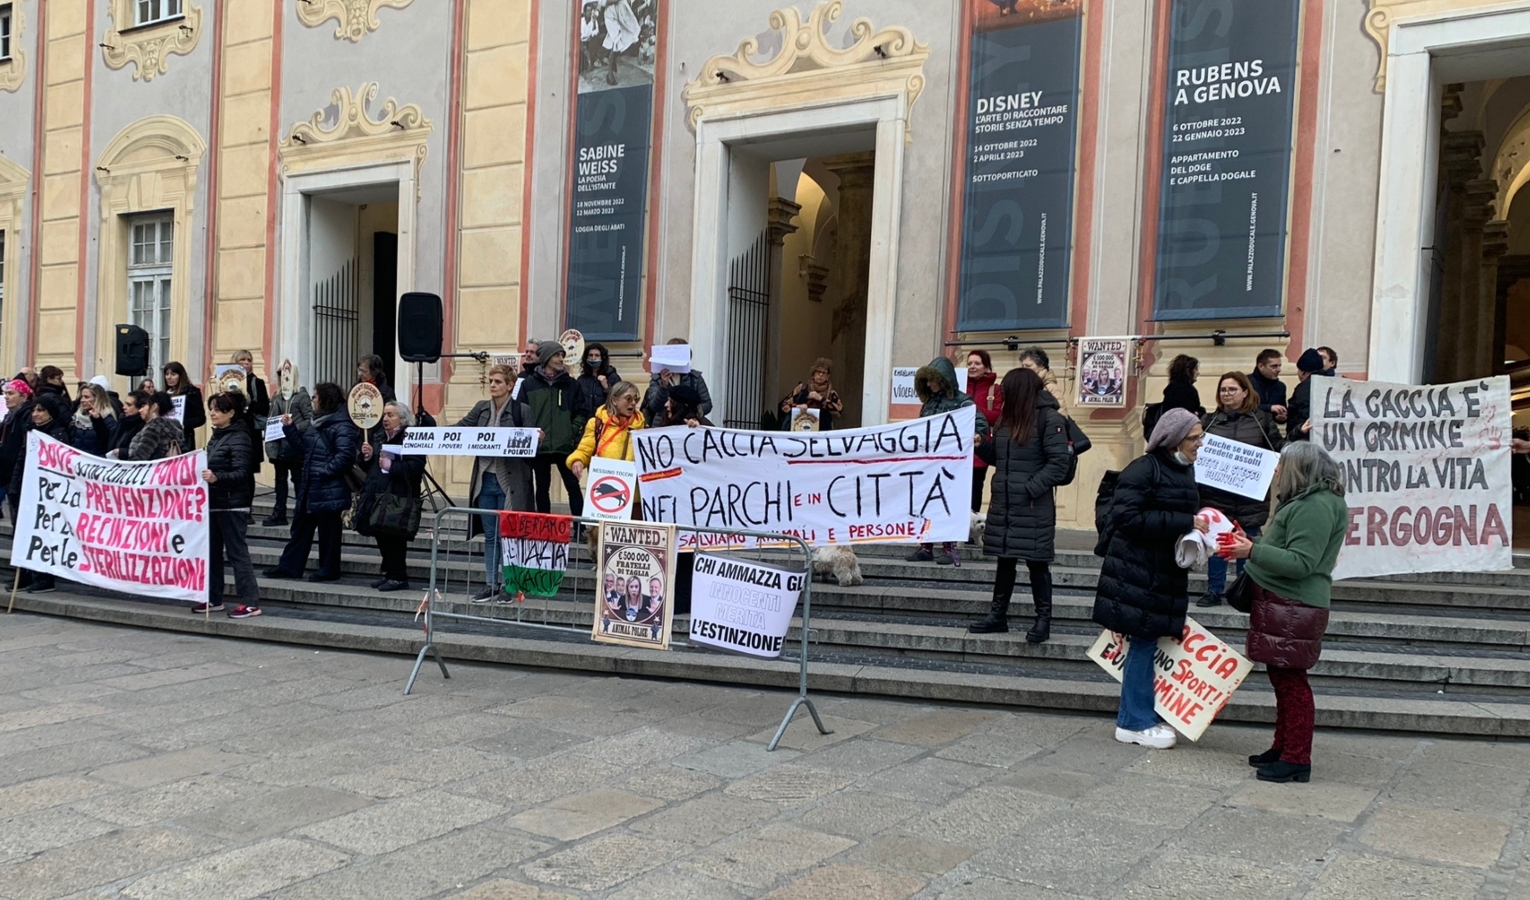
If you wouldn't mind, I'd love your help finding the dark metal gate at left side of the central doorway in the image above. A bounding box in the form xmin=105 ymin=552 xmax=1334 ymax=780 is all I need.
xmin=721 ymin=231 xmax=771 ymax=429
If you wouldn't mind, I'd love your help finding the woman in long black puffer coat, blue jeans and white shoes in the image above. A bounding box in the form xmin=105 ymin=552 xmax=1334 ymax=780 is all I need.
xmin=1094 ymin=409 xmax=1210 ymax=750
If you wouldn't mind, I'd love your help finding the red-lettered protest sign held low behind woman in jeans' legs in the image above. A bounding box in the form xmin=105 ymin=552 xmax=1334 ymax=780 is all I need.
xmin=1089 ymin=617 xmax=1253 ymax=741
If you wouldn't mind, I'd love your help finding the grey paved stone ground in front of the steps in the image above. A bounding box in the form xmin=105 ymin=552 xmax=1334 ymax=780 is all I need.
xmin=0 ymin=614 xmax=1530 ymax=900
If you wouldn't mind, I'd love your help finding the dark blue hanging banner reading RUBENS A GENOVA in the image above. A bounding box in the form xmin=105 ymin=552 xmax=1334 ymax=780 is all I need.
xmin=1154 ymin=0 xmax=1301 ymax=321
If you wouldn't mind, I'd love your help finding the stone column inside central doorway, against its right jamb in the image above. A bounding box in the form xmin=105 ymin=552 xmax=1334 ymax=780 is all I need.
xmin=823 ymin=153 xmax=890 ymax=427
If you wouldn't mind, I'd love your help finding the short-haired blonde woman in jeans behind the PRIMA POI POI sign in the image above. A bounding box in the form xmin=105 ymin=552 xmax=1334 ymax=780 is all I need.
xmin=457 ymin=366 xmax=537 ymax=603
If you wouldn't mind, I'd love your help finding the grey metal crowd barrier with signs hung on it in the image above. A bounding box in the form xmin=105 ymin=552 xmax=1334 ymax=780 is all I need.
xmin=404 ymin=507 xmax=834 ymax=750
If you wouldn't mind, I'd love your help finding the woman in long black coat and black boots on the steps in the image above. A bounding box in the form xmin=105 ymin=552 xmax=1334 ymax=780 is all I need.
xmin=967 ymin=369 xmax=1071 ymax=644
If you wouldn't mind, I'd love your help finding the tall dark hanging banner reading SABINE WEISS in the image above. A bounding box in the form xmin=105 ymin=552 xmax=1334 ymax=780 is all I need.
xmin=565 ymin=0 xmax=658 ymax=341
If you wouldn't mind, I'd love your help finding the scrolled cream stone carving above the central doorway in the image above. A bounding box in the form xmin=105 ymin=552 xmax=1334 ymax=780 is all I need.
xmin=685 ymin=0 xmax=930 ymax=140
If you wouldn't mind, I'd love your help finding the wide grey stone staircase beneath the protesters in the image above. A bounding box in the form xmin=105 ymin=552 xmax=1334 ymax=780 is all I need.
xmin=0 ymin=498 xmax=1530 ymax=738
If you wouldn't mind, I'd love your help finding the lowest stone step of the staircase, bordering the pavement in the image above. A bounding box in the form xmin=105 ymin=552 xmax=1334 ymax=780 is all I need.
xmin=17 ymin=591 xmax=1530 ymax=738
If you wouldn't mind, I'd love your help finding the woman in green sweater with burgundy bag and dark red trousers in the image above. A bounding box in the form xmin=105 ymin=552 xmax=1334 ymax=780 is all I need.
xmin=1222 ymin=441 xmax=1349 ymax=782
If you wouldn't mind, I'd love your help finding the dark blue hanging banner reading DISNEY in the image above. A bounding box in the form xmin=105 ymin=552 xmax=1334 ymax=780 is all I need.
xmin=956 ymin=0 xmax=1083 ymax=331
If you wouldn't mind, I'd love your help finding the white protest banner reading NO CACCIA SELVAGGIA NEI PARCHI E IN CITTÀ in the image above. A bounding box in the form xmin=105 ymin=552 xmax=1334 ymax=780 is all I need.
xmin=632 ymin=406 xmax=976 ymax=549
